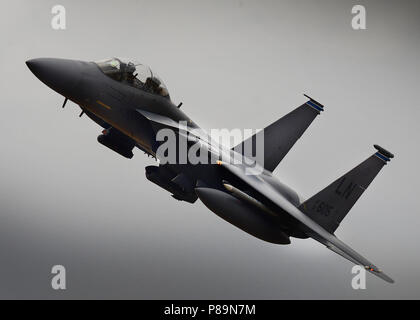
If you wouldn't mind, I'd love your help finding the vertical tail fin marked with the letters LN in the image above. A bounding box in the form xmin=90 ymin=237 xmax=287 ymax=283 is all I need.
xmin=299 ymin=144 xmax=394 ymax=233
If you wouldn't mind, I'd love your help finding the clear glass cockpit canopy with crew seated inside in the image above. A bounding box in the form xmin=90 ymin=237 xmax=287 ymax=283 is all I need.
xmin=95 ymin=58 xmax=170 ymax=99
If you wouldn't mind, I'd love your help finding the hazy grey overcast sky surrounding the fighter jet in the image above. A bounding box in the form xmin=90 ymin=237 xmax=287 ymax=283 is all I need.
xmin=0 ymin=0 xmax=420 ymax=299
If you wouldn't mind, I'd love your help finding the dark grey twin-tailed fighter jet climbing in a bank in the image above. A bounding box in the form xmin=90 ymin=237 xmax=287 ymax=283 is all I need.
xmin=26 ymin=58 xmax=394 ymax=283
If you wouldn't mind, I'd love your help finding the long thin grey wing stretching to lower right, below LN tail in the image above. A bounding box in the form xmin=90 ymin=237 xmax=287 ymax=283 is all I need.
xmin=218 ymin=161 xmax=394 ymax=283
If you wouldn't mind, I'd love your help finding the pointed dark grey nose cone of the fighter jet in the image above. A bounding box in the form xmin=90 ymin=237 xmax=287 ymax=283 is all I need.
xmin=26 ymin=58 xmax=83 ymax=97
